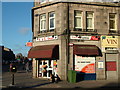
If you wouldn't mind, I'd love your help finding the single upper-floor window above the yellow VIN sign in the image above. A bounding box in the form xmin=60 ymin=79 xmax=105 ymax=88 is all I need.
xmin=109 ymin=13 xmax=116 ymax=31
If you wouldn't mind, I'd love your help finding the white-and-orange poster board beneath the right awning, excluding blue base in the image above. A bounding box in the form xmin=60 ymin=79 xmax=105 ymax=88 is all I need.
xmin=75 ymin=55 xmax=95 ymax=73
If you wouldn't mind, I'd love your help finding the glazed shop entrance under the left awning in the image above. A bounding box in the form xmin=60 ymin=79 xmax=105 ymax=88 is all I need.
xmin=38 ymin=60 xmax=57 ymax=78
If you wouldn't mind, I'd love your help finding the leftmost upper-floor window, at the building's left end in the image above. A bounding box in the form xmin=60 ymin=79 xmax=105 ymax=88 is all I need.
xmin=40 ymin=14 xmax=46 ymax=32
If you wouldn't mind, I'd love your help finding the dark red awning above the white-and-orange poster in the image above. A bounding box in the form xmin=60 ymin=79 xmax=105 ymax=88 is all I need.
xmin=73 ymin=45 xmax=101 ymax=56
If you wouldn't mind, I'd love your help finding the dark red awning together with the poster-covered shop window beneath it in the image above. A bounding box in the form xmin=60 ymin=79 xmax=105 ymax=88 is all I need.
xmin=73 ymin=45 xmax=101 ymax=81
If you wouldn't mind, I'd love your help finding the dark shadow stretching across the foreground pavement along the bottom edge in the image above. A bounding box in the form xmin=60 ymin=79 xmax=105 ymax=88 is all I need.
xmin=2 ymin=82 xmax=120 ymax=90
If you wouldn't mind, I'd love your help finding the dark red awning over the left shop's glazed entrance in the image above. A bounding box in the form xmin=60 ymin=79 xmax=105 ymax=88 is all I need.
xmin=28 ymin=45 xmax=59 ymax=59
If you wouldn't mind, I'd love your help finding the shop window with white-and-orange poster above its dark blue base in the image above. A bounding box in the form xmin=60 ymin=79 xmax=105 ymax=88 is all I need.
xmin=75 ymin=55 xmax=96 ymax=81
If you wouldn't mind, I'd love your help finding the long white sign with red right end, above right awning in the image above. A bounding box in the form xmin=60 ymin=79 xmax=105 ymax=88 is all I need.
xmin=70 ymin=35 xmax=100 ymax=40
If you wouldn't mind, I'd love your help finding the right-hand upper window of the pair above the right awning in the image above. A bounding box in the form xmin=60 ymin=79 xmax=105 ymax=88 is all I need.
xmin=86 ymin=12 xmax=94 ymax=31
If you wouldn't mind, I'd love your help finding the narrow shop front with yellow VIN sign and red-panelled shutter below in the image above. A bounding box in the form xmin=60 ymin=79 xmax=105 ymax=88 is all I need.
xmin=101 ymin=35 xmax=120 ymax=80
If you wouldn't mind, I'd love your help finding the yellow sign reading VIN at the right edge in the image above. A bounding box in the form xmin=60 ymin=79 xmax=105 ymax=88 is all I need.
xmin=101 ymin=36 xmax=120 ymax=48
